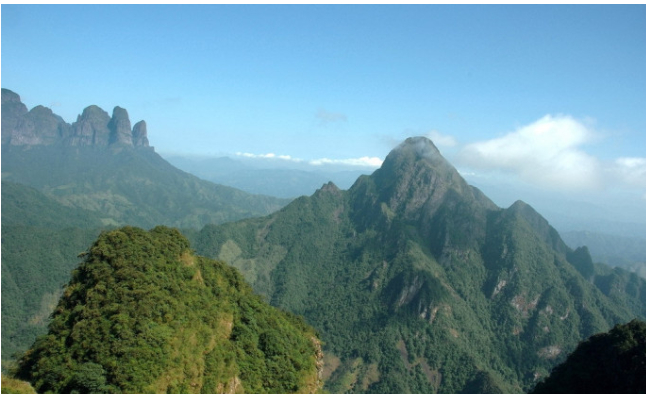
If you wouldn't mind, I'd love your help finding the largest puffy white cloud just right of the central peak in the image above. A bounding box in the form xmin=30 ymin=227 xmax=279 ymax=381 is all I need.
xmin=459 ymin=115 xmax=603 ymax=189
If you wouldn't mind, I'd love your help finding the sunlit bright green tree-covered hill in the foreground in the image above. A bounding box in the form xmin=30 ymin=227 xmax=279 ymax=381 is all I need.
xmin=10 ymin=227 xmax=321 ymax=393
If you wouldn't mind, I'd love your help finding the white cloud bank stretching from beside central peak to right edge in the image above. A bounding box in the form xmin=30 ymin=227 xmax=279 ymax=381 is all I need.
xmin=457 ymin=115 xmax=646 ymax=199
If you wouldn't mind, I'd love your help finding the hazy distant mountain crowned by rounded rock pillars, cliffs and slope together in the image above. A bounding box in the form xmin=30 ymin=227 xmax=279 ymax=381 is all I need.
xmin=2 ymin=89 xmax=288 ymax=229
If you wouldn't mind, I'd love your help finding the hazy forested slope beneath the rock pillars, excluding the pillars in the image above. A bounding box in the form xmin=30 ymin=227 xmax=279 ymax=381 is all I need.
xmin=2 ymin=145 xmax=287 ymax=228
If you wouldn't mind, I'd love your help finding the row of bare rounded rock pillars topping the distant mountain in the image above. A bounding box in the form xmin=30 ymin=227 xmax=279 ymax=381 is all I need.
xmin=2 ymin=89 xmax=150 ymax=148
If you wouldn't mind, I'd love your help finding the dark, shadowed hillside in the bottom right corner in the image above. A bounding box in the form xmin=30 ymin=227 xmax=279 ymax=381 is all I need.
xmin=531 ymin=320 xmax=646 ymax=394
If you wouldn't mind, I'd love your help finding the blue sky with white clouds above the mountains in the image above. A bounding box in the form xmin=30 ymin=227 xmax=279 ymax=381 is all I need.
xmin=1 ymin=5 xmax=646 ymax=222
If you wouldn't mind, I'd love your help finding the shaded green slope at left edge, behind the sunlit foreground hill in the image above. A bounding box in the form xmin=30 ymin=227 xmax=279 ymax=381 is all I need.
xmin=2 ymin=181 xmax=102 ymax=360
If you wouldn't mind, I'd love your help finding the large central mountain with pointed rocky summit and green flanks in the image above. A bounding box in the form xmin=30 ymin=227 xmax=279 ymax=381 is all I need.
xmin=193 ymin=138 xmax=646 ymax=394
